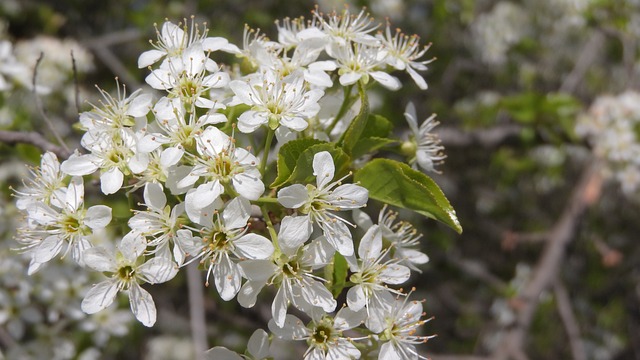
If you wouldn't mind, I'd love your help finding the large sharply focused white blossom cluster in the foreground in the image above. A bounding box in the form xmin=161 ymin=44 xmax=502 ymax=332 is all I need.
xmin=16 ymin=9 xmax=444 ymax=359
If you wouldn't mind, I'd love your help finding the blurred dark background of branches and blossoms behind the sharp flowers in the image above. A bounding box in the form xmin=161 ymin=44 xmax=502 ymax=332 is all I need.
xmin=0 ymin=0 xmax=640 ymax=360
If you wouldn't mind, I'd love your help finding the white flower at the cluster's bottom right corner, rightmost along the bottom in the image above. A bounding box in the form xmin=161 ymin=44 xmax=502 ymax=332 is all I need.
xmin=372 ymin=296 xmax=434 ymax=360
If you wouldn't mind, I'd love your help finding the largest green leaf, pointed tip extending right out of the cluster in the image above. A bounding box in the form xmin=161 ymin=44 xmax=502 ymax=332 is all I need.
xmin=354 ymin=159 xmax=462 ymax=233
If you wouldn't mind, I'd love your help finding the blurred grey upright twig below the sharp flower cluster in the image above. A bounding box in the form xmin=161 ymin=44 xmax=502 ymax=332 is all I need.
xmin=187 ymin=261 xmax=209 ymax=359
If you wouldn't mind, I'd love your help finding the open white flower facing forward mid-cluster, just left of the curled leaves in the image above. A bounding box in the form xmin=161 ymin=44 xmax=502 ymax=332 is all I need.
xmin=179 ymin=126 xmax=264 ymax=214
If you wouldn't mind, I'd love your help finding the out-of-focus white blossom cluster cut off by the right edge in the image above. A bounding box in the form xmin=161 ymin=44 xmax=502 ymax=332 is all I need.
xmin=576 ymin=91 xmax=640 ymax=194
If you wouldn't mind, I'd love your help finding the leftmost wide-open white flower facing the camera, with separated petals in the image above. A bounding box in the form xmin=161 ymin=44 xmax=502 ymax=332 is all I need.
xmin=27 ymin=177 xmax=111 ymax=273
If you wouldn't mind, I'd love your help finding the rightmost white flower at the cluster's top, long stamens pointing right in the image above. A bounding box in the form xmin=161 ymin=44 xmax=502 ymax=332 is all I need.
xmin=377 ymin=23 xmax=434 ymax=90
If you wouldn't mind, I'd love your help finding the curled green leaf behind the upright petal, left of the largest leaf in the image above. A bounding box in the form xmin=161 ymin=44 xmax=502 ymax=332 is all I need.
xmin=286 ymin=143 xmax=351 ymax=184
